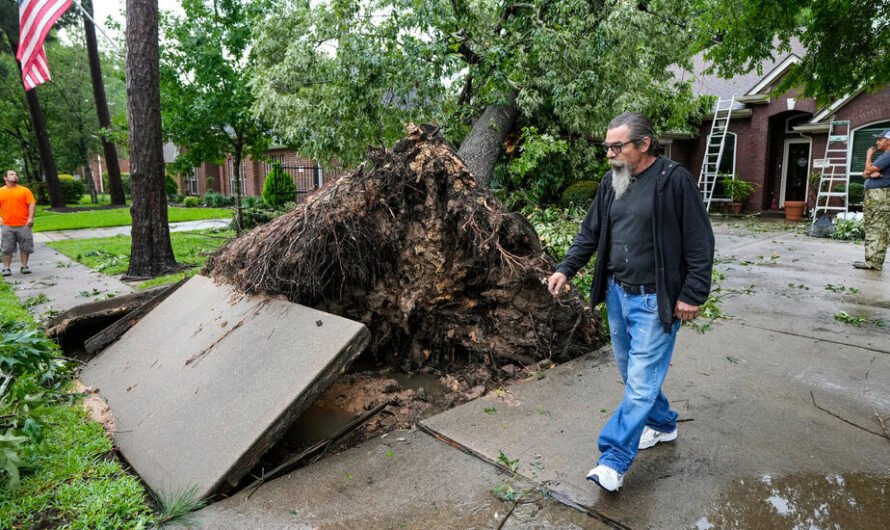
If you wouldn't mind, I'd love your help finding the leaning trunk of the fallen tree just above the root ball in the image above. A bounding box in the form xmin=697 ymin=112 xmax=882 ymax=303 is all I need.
xmin=457 ymin=95 xmax=519 ymax=188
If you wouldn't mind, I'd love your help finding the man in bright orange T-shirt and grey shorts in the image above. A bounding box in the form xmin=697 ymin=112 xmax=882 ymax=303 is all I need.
xmin=0 ymin=170 xmax=37 ymax=276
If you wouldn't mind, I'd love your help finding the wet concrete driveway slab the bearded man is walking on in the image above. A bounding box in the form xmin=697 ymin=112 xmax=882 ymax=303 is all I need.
xmin=422 ymin=323 xmax=890 ymax=528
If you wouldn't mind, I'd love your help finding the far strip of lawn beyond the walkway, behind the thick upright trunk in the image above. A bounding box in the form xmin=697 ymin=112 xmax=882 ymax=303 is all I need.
xmin=34 ymin=206 xmax=232 ymax=232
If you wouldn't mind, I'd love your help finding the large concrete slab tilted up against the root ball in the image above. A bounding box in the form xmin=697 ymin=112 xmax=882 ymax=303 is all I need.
xmin=81 ymin=276 xmax=369 ymax=497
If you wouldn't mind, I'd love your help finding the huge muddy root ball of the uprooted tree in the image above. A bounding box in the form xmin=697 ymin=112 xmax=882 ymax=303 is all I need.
xmin=204 ymin=125 xmax=597 ymax=368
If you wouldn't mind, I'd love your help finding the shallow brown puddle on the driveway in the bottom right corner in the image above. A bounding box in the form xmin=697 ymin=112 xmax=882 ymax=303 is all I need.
xmin=693 ymin=473 xmax=890 ymax=530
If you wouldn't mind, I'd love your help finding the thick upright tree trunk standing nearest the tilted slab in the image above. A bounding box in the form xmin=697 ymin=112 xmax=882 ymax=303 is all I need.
xmin=127 ymin=0 xmax=176 ymax=279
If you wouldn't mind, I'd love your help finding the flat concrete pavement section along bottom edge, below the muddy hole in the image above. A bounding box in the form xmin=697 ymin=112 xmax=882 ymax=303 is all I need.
xmin=174 ymin=431 xmax=611 ymax=530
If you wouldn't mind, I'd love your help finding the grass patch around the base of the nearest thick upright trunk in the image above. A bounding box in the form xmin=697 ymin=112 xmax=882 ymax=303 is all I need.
xmin=48 ymin=230 xmax=235 ymax=289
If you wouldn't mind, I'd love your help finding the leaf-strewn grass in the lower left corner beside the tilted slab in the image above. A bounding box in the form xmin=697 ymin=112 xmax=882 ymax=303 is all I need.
xmin=0 ymin=282 xmax=159 ymax=529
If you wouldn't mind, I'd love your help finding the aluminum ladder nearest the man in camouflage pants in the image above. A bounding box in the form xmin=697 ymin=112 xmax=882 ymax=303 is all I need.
xmin=813 ymin=120 xmax=850 ymax=223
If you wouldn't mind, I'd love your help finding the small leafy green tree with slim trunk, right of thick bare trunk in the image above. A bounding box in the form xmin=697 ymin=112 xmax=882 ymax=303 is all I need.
xmin=161 ymin=0 xmax=271 ymax=226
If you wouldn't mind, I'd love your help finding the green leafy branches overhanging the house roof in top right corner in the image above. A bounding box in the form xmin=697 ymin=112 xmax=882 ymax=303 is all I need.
xmin=693 ymin=0 xmax=890 ymax=104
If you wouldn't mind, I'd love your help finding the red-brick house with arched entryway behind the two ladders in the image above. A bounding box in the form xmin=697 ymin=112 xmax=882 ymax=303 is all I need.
xmin=662 ymin=46 xmax=890 ymax=211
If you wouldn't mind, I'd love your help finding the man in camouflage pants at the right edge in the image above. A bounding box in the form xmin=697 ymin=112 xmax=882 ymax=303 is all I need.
xmin=853 ymin=129 xmax=890 ymax=271
